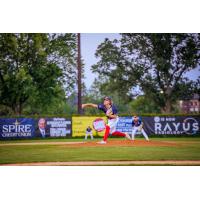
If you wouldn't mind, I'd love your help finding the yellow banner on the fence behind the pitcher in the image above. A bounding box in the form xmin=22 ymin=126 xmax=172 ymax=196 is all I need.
xmin=72 ymin=116 xmax=107 ymax=137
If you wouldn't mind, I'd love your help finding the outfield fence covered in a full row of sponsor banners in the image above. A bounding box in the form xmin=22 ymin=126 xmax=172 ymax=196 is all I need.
xmin=0 ymin=115 xmax=200 ymax=139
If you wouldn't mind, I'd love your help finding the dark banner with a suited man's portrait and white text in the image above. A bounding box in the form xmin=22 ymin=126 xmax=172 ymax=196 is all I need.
xmin=35 ymin=118 xmax=71 ymax=138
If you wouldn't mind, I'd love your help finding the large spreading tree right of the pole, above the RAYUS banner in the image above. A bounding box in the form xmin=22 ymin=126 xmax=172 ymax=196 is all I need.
xmin=93 ymin=34 xmax=200 ymax=113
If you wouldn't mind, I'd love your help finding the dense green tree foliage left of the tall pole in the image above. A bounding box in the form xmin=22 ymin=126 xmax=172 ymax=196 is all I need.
xmin=0 ymin=33 xmax=76 ymax=114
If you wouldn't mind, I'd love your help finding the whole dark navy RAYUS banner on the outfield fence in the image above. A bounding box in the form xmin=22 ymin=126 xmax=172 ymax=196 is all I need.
xmin=142 ymin=116 xmax=200 ymax=135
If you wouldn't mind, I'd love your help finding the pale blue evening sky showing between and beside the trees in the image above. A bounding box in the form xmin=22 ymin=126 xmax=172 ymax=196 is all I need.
xmin=81 ymin=33 xmax=200 ymax=89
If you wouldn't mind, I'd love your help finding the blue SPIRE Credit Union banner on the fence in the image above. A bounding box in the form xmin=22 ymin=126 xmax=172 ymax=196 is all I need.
xmin=0 ymin=118 xmax=35 ymax=139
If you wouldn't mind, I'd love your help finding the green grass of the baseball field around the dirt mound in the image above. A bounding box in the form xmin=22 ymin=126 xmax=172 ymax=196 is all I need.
xmin=0 ymin=137 xmax=200 ymax=164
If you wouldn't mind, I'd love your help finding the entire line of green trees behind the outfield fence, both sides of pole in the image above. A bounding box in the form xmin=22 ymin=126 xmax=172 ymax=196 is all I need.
xmin=0 ymin=33 xmax=200 ymax=115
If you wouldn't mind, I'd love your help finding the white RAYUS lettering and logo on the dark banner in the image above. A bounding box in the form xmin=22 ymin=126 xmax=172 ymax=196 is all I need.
xmin=154 ymin=117 xmax=199 ymax=134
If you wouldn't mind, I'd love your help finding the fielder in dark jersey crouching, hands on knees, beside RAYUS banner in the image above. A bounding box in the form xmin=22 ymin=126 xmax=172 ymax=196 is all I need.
xmin=132 ymin=116 xmax=149 ymax=141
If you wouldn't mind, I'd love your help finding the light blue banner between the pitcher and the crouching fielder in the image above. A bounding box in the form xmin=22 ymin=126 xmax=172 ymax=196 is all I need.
xmin=116 ymin=117 xmax=132 ymax=134
